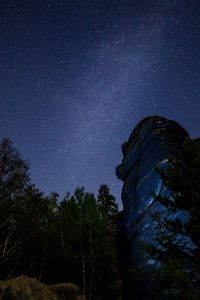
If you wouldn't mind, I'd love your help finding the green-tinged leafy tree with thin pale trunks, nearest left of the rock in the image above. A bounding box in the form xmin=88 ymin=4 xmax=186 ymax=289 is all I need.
xmin=56 ymin=188 xmax=119 ymax=300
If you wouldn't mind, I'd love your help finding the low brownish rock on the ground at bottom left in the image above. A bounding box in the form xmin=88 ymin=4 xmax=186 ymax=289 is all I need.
xmin=0 ymin=275 xmax=85 ymax=300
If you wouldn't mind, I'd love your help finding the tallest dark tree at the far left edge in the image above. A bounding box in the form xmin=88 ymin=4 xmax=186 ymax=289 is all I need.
xmin=0 ymin=138 xmax=30 ymax=274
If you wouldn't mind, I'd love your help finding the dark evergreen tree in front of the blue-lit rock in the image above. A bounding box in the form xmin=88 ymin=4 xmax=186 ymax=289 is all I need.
xmin=145 ymin=139 xmax=200 ymax=300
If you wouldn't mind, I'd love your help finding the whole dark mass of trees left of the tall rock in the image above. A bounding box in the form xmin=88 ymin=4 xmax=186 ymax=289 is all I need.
xmin=0 ymin=139 xmax=117 ymax=300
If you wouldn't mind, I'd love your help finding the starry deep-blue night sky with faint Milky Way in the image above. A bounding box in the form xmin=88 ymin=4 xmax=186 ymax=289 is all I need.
xmin=0 ymin=0 xmax=200 ymax=202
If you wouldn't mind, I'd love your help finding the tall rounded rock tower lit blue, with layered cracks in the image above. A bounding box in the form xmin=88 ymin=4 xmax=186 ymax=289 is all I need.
xmin=116 ymin=116 xmax=188 ymax=299
